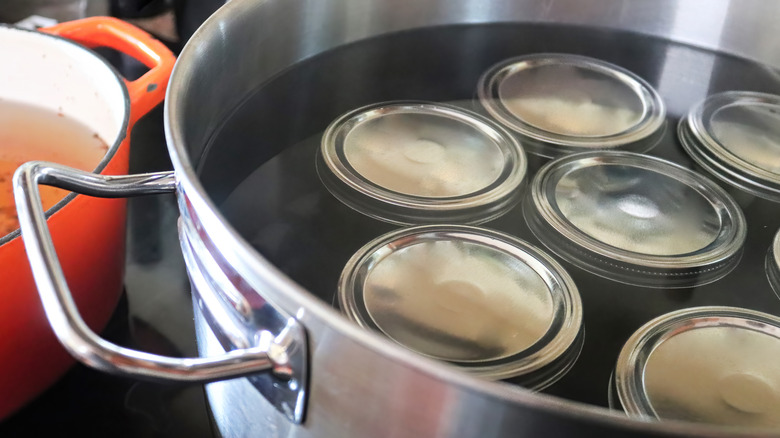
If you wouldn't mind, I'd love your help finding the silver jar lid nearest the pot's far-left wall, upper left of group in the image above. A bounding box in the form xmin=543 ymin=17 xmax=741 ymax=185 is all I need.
xmin=317 ymin=102 xmax=527 ymax=224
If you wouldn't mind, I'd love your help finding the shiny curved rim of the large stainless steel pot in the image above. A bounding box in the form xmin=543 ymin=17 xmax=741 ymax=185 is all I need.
xmin=163 ymin=1 xmax=777 ymax=438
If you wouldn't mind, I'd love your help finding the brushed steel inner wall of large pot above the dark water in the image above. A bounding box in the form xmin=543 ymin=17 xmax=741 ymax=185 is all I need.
xmin=175 ymin=0 xmax=780 ymax=169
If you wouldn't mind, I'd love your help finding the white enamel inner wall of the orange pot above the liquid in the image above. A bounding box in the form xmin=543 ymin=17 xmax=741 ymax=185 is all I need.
xmin=0 ymin=26 xmax=127 ymax=146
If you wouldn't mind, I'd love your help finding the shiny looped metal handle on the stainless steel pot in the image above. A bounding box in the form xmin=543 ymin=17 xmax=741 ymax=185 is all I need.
xmin=13 ymin=161 xmax=306 ymax=394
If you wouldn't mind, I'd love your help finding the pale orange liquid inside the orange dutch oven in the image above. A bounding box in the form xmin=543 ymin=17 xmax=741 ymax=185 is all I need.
xmin=0 ymin=99 xmax=108 ymax=237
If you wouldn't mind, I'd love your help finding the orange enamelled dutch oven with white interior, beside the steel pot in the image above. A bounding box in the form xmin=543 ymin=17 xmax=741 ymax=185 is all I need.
xmin=0 ymin=17 xmax=175 ymax=419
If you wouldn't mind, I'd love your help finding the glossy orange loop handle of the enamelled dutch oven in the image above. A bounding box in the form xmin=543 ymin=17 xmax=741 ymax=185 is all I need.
xmin=39 ymin=17 xmax=176 ymax=128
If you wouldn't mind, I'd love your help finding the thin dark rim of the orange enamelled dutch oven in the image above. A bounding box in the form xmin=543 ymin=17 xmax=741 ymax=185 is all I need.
xmin=0 ymin=23 xmax=130 ymax=247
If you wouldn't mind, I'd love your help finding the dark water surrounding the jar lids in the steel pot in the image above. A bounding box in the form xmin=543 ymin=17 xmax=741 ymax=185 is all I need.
xmin=199 ymin=25 xmax=780 ymax=406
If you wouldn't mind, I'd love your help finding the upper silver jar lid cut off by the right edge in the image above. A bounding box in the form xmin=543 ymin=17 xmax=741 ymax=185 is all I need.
xmin=678 ymin=91 xmax=780 ymax=202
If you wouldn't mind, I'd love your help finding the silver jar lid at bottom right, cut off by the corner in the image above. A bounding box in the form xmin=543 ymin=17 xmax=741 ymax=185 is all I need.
xmin=614 ymin=307 xmax=780 ymax=428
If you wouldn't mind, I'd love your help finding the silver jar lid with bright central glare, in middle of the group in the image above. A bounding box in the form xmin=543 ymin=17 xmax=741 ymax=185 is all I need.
xmin=523 ymin=151 xmax=747 ymax=288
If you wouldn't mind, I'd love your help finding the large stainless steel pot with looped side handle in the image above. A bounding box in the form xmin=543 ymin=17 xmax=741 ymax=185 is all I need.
xmin=15 ymin=0 xmax=780 ymax=437
